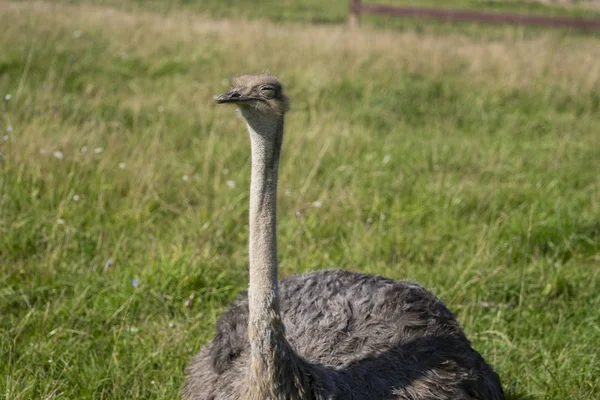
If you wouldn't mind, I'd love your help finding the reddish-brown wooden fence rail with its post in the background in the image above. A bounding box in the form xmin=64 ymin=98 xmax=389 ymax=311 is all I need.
xmin=349 ymin=0 xmax=600 ymax=30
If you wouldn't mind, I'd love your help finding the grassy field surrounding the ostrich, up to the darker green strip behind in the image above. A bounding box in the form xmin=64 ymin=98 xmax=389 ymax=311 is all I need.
xmin=0 ymin=0 xmax=600 ymax=400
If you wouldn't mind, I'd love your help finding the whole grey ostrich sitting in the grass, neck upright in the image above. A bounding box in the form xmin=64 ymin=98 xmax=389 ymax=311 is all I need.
xmin=183 ymin=75 xmax=504 ymax=400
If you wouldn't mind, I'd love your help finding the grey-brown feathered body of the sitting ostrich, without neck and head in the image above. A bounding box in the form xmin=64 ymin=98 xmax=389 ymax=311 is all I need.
xmin=183 ymin=270 xmax=504 ymax=400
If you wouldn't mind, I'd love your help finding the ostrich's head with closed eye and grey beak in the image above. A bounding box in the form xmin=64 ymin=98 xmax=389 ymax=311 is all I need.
xmin=214 ymin=74 xmax=290 ymax=119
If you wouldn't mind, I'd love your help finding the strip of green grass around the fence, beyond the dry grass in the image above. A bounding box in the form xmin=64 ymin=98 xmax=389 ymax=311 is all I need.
xmin=37 ymin=0 xmax=600 ymax=40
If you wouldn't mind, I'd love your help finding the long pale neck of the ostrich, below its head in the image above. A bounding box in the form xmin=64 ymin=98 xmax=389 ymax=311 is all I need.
xmin=242 ymin=112 xmax=312 ymax=400
